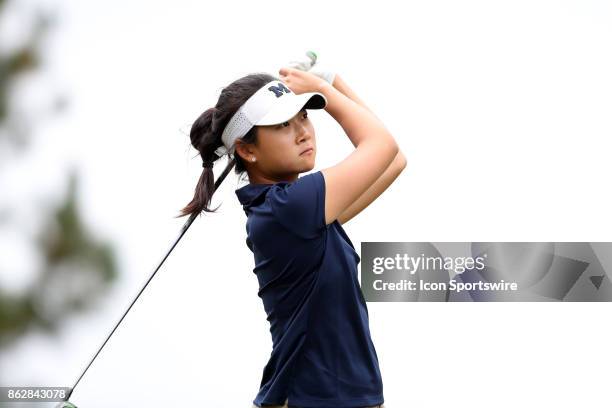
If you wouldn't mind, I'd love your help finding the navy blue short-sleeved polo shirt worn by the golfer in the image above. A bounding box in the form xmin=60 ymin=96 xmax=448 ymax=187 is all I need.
xmin=236 ymin=171 xmax=384 ymax=408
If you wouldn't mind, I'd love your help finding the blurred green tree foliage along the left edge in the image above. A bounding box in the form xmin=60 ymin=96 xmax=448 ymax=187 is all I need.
xmin=0 ymin=0 xmax=117 ymax=354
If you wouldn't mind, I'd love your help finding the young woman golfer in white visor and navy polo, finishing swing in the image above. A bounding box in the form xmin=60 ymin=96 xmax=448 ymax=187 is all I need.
xmin=182 ymin=67 xmax=405 ymax=408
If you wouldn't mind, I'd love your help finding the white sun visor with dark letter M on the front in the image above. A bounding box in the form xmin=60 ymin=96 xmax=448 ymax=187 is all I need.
xmin=215 ymin=80 xmax=327 ymax=157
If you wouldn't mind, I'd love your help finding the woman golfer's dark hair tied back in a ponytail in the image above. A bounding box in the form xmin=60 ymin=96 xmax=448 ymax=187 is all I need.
xmin=177 ymin=73 xmax=279 ymax=217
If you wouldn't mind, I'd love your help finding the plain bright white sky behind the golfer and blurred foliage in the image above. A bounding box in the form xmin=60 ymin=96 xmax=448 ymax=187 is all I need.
xmin=0 ymin=0 xmax=612 ymax=408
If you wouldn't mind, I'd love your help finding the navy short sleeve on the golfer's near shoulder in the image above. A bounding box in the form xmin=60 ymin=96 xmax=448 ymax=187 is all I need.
xmin=267 ymin=171 xmax=325 ymax=239
